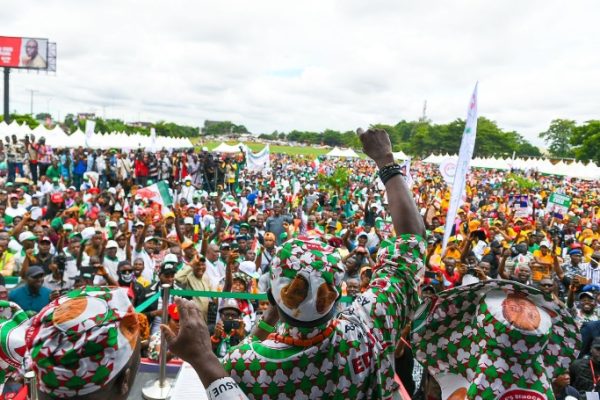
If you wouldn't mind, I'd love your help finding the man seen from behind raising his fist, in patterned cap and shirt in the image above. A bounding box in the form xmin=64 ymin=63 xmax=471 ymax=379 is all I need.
xmin=162 ymin=130 xmax=426 ymax=399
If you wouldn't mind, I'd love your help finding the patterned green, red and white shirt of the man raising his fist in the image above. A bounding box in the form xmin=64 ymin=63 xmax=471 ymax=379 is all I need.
xmin=223 ymin=235 xmax=426 ymax=399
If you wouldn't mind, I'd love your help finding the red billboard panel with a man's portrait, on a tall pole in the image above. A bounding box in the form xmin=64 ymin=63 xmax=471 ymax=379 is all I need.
xmin=0 ymin=36 xmax=48 ymax=70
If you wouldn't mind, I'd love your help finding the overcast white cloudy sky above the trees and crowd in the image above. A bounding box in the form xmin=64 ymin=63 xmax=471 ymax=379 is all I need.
xmin=2 ymin=0 xmax=600 ymax=144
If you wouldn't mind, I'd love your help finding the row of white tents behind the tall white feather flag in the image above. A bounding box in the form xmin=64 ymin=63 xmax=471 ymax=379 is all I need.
xmin=423 ymin=154 xmax=600 ymax=180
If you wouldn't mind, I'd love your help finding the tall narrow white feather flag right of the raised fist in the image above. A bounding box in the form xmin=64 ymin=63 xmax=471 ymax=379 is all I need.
xmin=442 ymin=83 xmax=478 ymax=251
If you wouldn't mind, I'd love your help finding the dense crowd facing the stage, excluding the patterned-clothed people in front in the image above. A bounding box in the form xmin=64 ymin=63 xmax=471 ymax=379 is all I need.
xmin=0 ymin=137 xmax=600 ymax=398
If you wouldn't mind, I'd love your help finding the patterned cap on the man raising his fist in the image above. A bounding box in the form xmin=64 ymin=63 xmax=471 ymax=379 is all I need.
xmin=270 ymin=237 xmax=344 ymax=327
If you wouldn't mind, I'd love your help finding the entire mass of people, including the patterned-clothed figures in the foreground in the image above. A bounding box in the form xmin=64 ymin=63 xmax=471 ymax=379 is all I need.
xmin=0 ymin=131 xmax=600 ymax=399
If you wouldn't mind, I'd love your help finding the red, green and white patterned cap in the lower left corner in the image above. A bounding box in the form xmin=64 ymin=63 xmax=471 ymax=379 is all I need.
xmin=26 ymin=287 xmax=140 ymax=398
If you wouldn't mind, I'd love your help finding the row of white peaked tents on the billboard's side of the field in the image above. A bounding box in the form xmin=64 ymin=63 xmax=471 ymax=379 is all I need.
xmin=0 ymin=121 xmax=193 ymax=151
